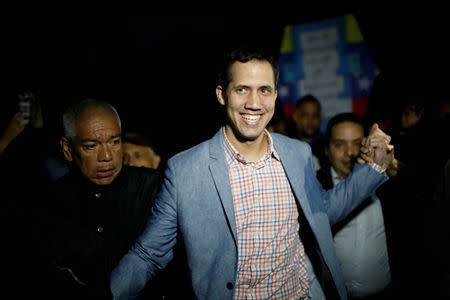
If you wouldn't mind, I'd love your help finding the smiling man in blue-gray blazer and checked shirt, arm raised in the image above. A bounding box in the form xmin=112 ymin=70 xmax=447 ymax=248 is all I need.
xmin=111 ymin=48 xmax=393 ymax=300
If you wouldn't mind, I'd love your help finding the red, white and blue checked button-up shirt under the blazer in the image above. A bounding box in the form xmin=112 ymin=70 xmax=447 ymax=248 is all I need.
xmin=223 ymin=130 xmax=308 ymax=299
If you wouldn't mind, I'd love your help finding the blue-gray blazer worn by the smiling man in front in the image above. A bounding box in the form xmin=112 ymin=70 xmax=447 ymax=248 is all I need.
xmin=111 ymin=130 xmax=387 ymax=300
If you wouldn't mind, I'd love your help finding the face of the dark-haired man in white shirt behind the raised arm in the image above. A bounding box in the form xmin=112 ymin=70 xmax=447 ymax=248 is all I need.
xmin=325 ymin=121 xmax=364 ymax=178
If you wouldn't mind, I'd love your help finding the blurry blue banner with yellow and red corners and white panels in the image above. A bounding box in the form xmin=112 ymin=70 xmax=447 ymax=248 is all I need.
xmin=278 ymin=14 xmax=376 ymax=130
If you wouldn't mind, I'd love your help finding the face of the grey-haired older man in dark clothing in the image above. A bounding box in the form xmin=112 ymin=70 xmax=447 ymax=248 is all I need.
xmin=63 ymin=110 xmax=123 ymax=185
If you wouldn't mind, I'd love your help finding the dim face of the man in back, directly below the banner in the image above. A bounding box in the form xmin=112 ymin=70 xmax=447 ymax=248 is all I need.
xmin=292 ymin=102 xmax=322 ymax=138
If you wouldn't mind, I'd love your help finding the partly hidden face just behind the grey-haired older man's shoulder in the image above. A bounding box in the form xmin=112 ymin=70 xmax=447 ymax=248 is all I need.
xmin=123 ymin=142 xmax=161 ymax=169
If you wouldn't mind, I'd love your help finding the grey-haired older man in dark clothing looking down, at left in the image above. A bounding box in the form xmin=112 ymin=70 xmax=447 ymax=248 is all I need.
xmin=43 ymin=99 xmax=160 ymax=299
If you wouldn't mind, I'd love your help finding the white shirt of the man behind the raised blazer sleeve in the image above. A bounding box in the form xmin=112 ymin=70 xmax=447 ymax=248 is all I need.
xmin=331 ymin=168 xmax=391 ymax=297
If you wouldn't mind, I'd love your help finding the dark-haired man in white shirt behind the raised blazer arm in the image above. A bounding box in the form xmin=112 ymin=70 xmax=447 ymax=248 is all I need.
xmin=317 ymin=113 xmax=391 ymax=299
